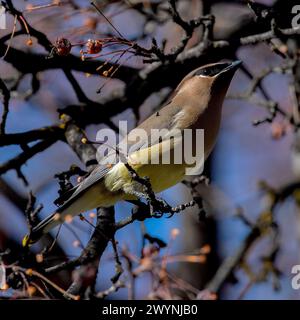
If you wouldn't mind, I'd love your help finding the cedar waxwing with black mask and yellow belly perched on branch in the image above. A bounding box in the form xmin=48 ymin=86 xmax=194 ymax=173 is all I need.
xmin=23 ymin=61 xmax=241 ymax=246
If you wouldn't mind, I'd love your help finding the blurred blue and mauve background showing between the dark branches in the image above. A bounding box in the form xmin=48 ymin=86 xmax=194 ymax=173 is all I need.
xmin=0 ymin=0 xmax=300 ymax=299
